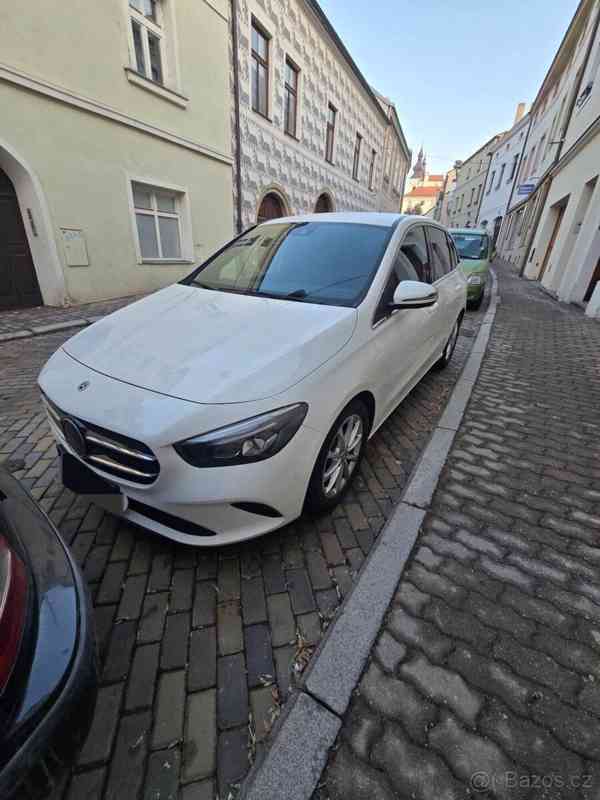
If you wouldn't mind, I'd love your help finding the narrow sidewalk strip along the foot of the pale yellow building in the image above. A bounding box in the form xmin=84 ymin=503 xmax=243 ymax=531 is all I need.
xmin=0 ymin=295 xmax=142 ymax=343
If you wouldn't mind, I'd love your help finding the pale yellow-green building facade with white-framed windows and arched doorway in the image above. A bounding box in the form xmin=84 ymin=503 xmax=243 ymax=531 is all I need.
xmin=0 ymin=0 xmax=232 ymax=308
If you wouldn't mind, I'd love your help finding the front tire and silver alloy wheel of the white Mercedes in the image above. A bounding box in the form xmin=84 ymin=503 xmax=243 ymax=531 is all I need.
xmin=304 ymin=400 xmax=371 ymax=514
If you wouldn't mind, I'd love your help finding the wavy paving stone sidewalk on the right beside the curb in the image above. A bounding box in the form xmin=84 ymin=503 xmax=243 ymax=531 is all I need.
xmin=315 ymin=266 xmax=600 ymax=800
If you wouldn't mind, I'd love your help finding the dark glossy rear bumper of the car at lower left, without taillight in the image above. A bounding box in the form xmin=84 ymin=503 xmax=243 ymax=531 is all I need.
xmin=0 ymin=471 xmax=98 ymax=798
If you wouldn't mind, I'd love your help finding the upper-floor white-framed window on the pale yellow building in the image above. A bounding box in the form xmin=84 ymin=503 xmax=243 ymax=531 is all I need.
xmin=129 ymin=0 xmax=165 ymax=85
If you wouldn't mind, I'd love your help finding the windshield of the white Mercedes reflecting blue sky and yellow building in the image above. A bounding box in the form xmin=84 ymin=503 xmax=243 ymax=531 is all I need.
xmin=184 ymin=222 xmax=393 ymax=306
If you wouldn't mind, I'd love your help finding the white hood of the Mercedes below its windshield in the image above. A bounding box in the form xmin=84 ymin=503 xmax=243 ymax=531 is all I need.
xmin=64 ymin=284 xmax=357 ymax=403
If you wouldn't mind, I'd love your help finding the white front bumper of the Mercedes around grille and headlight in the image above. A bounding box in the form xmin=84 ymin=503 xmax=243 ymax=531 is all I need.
xmin=40 ymin=352 xmax=323 ymax=547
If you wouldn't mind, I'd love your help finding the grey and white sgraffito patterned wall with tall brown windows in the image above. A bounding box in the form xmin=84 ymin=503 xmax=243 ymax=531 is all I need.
xmin=230 ymin=0 xmax=386 ymax=227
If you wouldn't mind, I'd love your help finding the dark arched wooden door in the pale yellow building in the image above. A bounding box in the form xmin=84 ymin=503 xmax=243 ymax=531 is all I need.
xmin=0 ymin=169 xmax=42 ymax=311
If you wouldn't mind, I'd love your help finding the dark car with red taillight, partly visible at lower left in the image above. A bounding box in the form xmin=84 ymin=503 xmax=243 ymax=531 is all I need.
xmin=0 ymin=468 xmax=97 ymax=800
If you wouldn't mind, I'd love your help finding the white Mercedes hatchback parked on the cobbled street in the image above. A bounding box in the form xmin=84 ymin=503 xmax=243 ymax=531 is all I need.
xmin=39 ymin=213 xmax=466 ymax=545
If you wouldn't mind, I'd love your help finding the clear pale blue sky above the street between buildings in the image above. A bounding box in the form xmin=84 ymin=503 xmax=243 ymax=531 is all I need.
xmin=321 ymin=0 xmax=578 ymax=172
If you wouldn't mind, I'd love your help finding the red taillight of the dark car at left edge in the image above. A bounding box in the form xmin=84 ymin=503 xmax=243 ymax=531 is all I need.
xmin=0 ymin=536 xmax=27 ymax=692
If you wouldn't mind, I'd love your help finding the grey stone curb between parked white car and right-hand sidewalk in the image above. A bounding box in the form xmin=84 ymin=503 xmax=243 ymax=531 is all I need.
xmin=241 ymin=271 xmax=499 ymax=800
